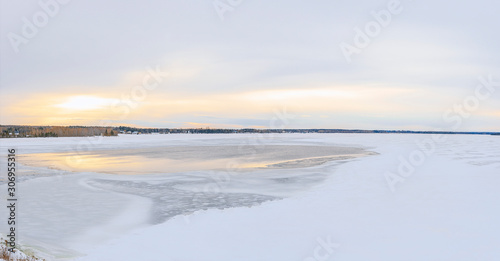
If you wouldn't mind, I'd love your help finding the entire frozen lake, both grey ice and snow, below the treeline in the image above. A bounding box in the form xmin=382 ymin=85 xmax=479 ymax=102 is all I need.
xmin=0 ymin=134 xmax=500 ymax=261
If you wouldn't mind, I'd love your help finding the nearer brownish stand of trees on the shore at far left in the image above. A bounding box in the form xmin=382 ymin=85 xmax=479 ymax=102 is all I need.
xmin=0 ymin=125 xmax=118 ymax=138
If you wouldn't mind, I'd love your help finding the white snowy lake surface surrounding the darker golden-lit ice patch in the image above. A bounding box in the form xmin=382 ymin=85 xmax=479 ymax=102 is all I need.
xmin=0 ymin=134 xmax=500 ymax=261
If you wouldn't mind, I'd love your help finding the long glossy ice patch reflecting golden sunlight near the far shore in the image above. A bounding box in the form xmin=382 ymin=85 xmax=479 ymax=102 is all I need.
xmin=23 ymin=143 xmax=368 ymax=175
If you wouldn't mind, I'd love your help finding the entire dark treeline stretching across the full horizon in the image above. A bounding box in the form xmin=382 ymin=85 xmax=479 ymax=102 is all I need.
xmin=0 ymin=125 xmax=500 ymax=138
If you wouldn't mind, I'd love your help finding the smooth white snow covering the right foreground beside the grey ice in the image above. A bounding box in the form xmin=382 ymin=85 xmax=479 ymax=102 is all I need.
xmin=75 ymin=134 xmax=500 ymax=261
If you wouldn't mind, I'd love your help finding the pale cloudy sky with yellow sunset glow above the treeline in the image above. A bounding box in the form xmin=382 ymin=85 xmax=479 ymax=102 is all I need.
xmin=0 ymin=0 xmax=500 ymax=131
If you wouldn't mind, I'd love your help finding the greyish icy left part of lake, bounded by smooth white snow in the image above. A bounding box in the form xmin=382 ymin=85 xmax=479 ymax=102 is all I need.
xmin=2 ymin=135 xmax=373 ymax=258
